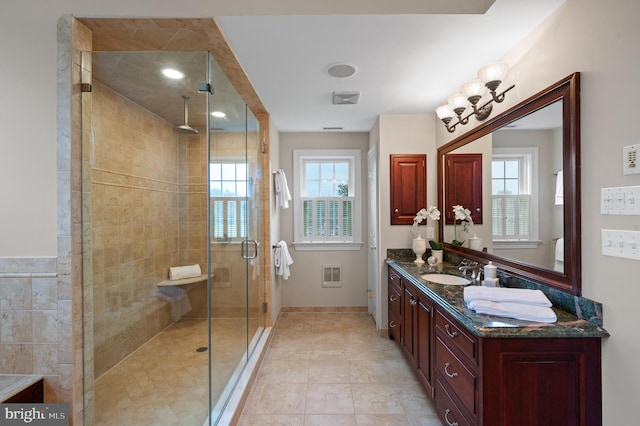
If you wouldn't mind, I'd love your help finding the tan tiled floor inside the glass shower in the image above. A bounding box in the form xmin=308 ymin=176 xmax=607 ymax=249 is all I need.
xmin=95 ymin=319 xmax=257 ymax=426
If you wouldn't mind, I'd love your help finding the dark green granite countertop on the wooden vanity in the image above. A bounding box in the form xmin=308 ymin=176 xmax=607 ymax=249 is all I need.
xmin=387 ymin=260 xmax=609 ymax=338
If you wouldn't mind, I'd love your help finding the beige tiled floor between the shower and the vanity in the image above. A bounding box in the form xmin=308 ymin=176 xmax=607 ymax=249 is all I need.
xmin=239 ymin=312 xmax=442 ymax=426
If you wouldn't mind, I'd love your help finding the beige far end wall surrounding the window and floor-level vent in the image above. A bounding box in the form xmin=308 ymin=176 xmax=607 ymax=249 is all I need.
xmin=277 ymin=132 xmax=369 ymax=307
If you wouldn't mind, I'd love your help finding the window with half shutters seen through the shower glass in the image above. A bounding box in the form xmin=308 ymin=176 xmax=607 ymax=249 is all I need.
xmin=209 ymin=161 xmax=249 ymax=242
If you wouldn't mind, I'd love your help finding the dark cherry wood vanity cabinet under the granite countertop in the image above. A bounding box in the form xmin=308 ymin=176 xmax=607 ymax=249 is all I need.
xmin=389 ymin=267 xmax=602 ymax=426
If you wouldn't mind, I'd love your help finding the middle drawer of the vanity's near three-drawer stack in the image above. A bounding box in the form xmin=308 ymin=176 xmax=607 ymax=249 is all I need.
xmin=436 ymin=336 xmax=478 ymax=417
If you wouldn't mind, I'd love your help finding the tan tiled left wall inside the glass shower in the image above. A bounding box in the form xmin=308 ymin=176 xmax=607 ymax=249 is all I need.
xmin=91 ymin=81 xmax=180 ymax=378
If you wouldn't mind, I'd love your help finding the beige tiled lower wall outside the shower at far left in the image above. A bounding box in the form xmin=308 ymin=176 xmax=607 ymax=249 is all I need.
xmin=0 ymin=257 xmax=65 ymax=402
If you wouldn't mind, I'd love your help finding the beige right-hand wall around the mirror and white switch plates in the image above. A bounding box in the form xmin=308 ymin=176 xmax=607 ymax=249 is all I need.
xmin=438 ymin=0 xmax=640 ymax=425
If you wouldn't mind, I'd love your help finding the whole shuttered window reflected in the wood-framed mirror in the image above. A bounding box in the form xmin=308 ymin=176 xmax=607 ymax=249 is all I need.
xmin=491 ymin=148 xmax=538 ymax=248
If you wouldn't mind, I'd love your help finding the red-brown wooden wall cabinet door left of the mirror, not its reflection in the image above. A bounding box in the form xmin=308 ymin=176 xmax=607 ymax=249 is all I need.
xmin=390 ymin=154 xmax=427 ymax=225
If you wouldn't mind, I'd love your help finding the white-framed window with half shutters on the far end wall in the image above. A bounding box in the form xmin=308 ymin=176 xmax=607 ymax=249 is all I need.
xmin=293 ymin=150 xmax=362 ymax=250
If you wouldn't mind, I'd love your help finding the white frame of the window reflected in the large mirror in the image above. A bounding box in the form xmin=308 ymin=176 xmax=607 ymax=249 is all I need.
xmin=491 ymin=147 xmax=542 ymax=249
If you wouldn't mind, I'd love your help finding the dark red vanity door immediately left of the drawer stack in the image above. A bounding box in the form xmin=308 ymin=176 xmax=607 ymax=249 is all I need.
xmin=414 ymin=295 xmax=435 ymax=398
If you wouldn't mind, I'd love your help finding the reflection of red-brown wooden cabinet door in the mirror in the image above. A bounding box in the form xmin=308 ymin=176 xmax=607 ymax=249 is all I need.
xmin=443 ymin=154 xmax=482 ymax=225
